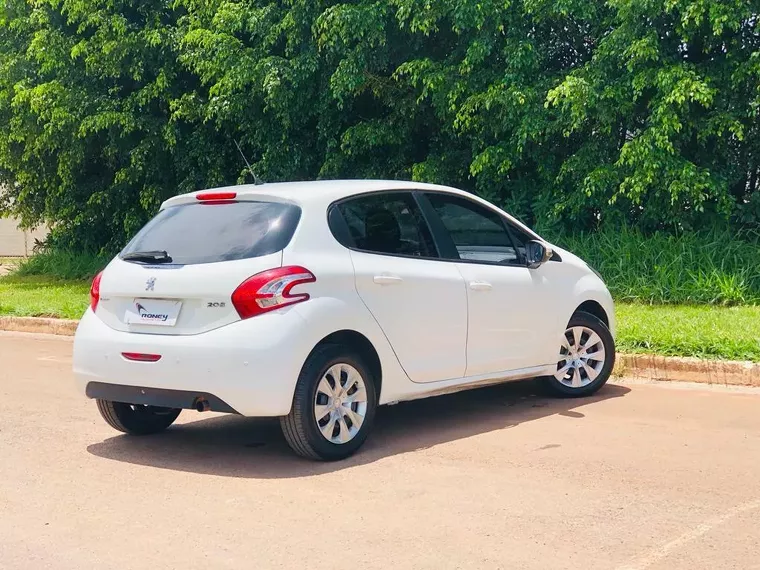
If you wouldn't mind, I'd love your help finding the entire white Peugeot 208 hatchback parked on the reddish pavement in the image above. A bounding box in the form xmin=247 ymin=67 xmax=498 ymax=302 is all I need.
xmin=74 ymin=181 xmax=615 ymax=460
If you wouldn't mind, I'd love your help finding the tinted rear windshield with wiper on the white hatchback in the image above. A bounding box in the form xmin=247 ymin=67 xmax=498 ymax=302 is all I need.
xmin=121 ymin=201 xmax=301 ymax=265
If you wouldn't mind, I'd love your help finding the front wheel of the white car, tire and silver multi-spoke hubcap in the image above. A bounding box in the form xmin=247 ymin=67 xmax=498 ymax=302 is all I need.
xmin=542 ymin=311 xmax=615 ymax=398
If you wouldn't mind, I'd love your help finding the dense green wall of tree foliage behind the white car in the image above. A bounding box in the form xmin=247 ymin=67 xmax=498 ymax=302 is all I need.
xmin=0 ymin=0 xmax=760 ymax=251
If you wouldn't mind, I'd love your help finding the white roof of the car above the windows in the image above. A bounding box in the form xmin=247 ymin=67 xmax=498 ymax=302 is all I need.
xmin=162 ymin=180 xmax=466 ymax=208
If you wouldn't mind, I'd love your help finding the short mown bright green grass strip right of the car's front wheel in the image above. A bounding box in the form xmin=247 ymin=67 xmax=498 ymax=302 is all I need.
xmin=617 ymin=304 xmax=760 ymax=362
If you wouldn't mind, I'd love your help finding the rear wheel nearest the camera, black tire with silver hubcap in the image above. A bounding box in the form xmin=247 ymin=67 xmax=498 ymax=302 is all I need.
xmin=280 ymin=345 xmax=377 ymax=461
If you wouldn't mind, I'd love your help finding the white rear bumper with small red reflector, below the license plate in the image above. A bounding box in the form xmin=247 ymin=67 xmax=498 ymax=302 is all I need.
xmin=74 ymin=309 xmax=311 ymax=416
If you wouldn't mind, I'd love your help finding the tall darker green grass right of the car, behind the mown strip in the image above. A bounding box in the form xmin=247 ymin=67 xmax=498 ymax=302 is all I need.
xmin=546 ymin=229 xmax=760 ymax=305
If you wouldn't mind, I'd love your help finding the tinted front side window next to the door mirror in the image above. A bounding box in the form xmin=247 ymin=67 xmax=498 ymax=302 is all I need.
xmin=426 ymin=193 xmax=520 ymax=264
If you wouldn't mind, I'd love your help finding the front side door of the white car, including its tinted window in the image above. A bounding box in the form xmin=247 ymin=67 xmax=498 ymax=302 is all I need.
xmin=425 ymin=193 xmax=558 ymax=376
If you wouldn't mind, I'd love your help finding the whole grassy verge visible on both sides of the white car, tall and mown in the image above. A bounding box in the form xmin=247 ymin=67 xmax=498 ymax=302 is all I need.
xmin=5 ymin=234 xmax=760 ymax=361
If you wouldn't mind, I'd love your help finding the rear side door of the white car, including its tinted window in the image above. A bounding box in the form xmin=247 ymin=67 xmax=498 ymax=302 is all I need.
xmin=330 ymin=192 xmax=467 ymax=382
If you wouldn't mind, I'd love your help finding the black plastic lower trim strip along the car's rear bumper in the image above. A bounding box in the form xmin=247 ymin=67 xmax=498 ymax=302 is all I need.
xmin=85 ymin=382 xmax=238 ymax=414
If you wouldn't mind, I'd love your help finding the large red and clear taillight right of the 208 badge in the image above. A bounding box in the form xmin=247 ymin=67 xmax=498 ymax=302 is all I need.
xmin=232 ymin=266 xmax=317 ymax=319
